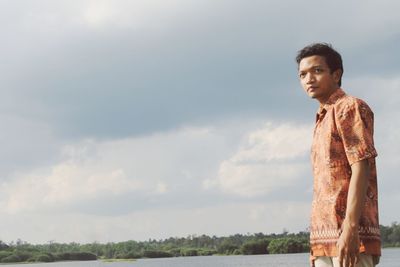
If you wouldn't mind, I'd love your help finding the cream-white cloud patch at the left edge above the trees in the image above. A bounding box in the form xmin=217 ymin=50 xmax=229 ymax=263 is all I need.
xmin=0 ymin=162 xmax=141 ymax=213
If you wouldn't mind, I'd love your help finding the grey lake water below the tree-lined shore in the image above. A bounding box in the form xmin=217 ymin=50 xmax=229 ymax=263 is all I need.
xmin=1 ymin=248 xmax=400 ymax=267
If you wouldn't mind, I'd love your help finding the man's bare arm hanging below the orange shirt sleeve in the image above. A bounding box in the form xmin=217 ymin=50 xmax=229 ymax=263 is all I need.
xmin=337 ymin=159 xmax=370 ymax=267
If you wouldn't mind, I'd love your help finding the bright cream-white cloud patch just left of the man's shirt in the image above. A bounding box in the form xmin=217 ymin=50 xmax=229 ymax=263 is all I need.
xmin=203 ymin=124 xmax=312 ymax=197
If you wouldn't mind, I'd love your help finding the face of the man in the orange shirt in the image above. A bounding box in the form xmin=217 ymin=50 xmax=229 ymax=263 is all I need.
xmin=299 ymin=56 xmax=341 ymax=104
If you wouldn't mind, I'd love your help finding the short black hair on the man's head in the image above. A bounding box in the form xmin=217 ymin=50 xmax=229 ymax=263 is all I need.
xmin=296 ymin=43 xmax=344 ymax=86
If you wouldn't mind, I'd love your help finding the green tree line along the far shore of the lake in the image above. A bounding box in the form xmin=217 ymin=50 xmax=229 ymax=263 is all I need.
xmin=0 ymin=223 xmax=400 ymax=263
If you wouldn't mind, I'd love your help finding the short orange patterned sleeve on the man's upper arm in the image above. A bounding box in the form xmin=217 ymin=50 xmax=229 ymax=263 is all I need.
xmin=335 ymin=99 xmax=378 ymax=165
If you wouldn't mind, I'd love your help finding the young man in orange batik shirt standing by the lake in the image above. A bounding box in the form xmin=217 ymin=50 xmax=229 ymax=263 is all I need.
xmin=296 ymin=43 xmax=381 ymax=267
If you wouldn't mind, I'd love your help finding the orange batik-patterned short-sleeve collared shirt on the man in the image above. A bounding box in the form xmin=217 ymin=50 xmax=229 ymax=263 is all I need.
xmin=310 ymin=89 xmax=381 ymax=256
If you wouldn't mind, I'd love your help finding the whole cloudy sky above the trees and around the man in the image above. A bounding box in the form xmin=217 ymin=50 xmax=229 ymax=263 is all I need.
xmin=0 ymin=0 xmax=400 ymax=243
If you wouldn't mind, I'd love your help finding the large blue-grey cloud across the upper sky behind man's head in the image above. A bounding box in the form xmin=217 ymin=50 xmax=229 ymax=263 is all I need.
xmin=3 ymin=1 xmax=398 ymax=138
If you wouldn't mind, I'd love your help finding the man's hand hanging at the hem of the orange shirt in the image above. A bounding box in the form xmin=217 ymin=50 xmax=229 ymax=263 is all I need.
xmin=337 ymin=225 xmax=360 ymax=267
